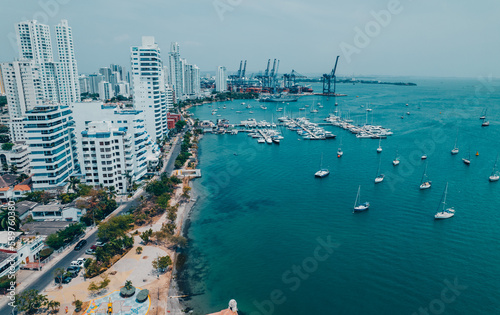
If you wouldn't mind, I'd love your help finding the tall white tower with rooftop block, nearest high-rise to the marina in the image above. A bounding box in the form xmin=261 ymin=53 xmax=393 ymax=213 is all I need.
xmin=131 ymin=36 xmax=168 ymax=142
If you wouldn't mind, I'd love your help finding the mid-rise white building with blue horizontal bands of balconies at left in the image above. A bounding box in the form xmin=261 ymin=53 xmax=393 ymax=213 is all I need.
xmin=24 ymin=106 xmax=77 ymax=190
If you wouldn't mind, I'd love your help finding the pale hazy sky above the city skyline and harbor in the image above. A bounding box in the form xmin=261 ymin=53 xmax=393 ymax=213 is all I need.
xmin=0 ymin=0 xmax=500 ymax=77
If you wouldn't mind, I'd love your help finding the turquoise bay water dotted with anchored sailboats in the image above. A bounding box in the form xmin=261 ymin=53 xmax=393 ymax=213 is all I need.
xmin=179 ymin=78 xmax=500 ymax=315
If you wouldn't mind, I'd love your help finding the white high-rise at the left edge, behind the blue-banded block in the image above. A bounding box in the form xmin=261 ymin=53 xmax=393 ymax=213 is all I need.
xmin=0 ymin=60 xmax=44 ymax=142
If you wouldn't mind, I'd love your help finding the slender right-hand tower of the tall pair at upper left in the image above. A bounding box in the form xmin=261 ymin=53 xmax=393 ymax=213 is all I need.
xmin=56 ymin=20 xmax=80 ymax=106
